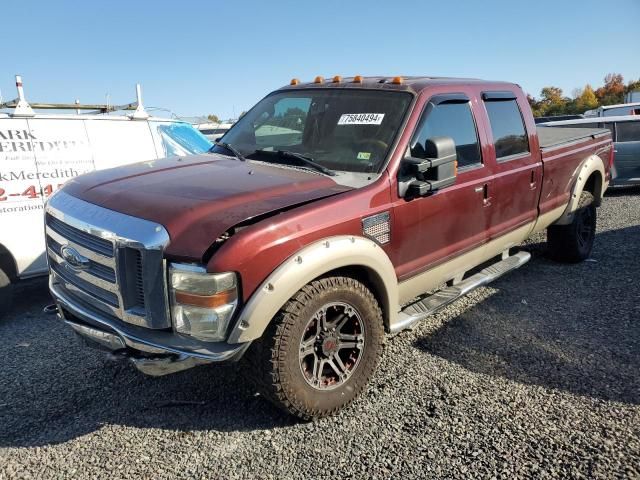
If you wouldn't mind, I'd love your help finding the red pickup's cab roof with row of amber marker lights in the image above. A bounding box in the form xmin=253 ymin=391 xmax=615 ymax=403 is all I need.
xmin=280 ymin=76 xmax=519 ymax=93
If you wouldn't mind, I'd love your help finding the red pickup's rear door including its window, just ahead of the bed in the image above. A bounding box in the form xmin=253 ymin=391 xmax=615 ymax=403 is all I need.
xmin=482 ymin=91 xmax=542 ymax=240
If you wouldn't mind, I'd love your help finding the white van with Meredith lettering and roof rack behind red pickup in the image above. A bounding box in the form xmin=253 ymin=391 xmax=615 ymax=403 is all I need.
xmin=0 ymin=76 xmax=213 ymax=310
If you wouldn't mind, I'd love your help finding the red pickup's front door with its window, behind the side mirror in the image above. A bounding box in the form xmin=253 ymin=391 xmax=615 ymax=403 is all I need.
xmin=392 ymin=93 xmax=492 ymax=281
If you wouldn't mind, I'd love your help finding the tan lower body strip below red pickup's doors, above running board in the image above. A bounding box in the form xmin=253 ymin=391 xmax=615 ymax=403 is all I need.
xmin=398 ymin=221 xmax=536 ymax=305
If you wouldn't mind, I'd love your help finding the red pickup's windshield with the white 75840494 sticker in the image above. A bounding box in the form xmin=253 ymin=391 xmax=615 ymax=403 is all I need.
xmin=213 ymin=89 xmax=411 ymax=172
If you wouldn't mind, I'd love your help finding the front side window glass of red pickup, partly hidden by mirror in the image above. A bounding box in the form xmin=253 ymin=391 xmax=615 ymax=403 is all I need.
xmin=411 ymin=102 xmax=482 ymax=168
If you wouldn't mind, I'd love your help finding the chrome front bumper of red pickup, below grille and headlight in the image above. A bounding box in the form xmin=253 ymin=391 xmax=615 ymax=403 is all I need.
xmin=49 ymin=282 xmax=250 ymax=376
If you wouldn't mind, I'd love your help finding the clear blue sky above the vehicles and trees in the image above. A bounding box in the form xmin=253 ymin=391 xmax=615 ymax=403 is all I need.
xmin=0 ymin=0 xmax=640 ymax=117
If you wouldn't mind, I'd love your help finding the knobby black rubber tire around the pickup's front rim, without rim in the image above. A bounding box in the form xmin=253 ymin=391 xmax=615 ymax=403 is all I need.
xmin=245 ymin=277 xmax=384 ymax=420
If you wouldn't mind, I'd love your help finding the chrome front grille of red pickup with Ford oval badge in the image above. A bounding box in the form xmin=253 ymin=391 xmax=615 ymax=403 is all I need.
xmin=45 ymin=192 xmax=171 ymax=328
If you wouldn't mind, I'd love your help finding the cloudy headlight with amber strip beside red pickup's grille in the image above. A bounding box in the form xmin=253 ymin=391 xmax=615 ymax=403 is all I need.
xmin=169 ymin=263 xmax=238 ymax=341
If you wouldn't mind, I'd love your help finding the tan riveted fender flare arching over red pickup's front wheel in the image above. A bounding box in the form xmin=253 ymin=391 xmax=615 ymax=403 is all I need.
xmin=227 ymin=235 xmax=398 ymax=343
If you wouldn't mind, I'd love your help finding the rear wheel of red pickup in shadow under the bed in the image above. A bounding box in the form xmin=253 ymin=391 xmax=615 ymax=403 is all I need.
xmin=547 ymin=192 xmax=596 ymax=263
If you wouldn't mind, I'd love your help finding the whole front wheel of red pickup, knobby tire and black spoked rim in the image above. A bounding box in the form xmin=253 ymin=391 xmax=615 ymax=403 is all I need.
xmin=247 ymin=277 xmax=384 ymax=420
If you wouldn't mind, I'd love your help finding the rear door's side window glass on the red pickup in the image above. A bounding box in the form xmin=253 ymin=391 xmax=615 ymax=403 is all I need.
xmin=484 ymin=99 xmax=529 ymax=159
